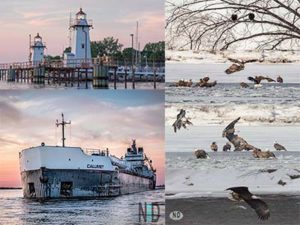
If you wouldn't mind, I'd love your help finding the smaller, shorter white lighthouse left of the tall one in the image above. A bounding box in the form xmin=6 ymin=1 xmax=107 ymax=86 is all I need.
xmin=30 ymin=33 xmax=46 ymax=64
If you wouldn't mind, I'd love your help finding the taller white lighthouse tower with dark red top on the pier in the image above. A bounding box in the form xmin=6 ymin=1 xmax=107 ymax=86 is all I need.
xmin=70 ymin=8 xmax=92 ymax=60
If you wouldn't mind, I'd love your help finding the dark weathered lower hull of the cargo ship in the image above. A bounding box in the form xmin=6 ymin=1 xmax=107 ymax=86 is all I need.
xmin=21 ymin=167 xmax=155 ymax=199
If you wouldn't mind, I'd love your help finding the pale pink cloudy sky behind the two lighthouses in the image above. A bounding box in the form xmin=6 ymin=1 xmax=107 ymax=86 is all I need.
xmin=0 ymin=0 xmax=164 ymax=63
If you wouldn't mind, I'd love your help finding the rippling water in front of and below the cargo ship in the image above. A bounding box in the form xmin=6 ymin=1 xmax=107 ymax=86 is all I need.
xmin=0 ymin=190 xmax=165 ymax=225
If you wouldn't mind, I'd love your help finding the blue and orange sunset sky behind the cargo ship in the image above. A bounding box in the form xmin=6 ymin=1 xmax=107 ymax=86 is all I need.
xmin=0 ymin=90 xmax=165 ymax=187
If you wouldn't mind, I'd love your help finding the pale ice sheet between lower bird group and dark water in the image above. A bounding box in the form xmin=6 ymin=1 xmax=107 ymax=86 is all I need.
xmin=166 ymin=151 xmax=300 ymax=198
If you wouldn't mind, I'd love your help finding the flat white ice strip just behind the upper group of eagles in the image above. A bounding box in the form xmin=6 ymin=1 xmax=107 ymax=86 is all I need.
xmin=166 ymin=63 xmax=300 ymax=83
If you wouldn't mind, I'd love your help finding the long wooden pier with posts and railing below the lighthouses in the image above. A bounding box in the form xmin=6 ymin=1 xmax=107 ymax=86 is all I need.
xmin=0 ymin=58 xmax=164 ymax=89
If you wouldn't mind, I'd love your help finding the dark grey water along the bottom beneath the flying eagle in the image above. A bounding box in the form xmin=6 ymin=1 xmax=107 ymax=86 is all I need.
xmin=166 ymin=195 xmax=300 ymax=225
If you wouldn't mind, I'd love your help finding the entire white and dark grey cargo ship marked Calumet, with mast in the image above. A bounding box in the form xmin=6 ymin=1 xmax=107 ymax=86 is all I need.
xmin=19 ymin=114 xmax=156 ymax=199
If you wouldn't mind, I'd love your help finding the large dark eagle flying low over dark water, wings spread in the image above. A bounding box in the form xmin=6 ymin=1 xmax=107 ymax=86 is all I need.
xmin=226 ymin=186 xmax=270 ymax=220
